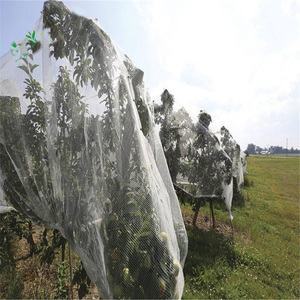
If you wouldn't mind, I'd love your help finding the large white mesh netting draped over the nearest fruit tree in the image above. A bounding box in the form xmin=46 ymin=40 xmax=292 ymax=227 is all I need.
xmin=0 ymin=1 xmax=187 ymax=299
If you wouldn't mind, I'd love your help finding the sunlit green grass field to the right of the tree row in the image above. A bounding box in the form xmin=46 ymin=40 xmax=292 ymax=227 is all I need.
xmin=182 ymin=156 xmax=300 ymax=299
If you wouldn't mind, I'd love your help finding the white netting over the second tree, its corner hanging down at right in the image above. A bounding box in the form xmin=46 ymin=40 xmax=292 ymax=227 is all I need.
xmin=173 ymin=109 xmax=233 ymax=218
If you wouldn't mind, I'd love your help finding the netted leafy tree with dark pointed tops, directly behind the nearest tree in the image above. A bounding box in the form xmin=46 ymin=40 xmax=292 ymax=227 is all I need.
xmin=155 ymin=90 xmax=232 ymax=218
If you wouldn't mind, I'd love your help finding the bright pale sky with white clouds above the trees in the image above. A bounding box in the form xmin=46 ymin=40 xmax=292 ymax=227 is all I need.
xmin=1 ymin=0 xmax=300 ymax=149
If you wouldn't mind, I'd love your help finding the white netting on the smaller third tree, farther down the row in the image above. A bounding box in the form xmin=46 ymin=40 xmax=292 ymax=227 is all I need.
xmin=218 ymin=126 xmax=244 ymax=190
